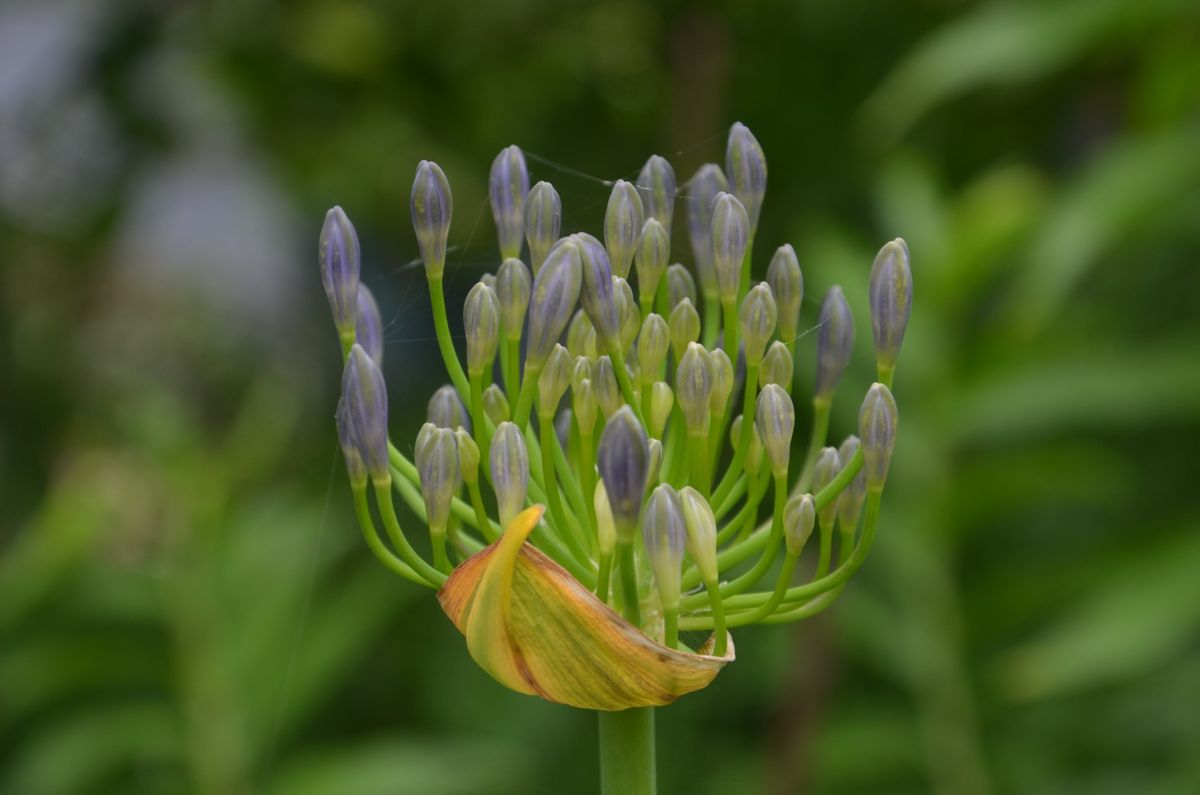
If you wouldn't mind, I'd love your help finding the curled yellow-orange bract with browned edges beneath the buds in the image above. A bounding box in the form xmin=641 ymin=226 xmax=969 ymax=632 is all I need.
xmin=438 ymin=506 xmax=734 ymax=711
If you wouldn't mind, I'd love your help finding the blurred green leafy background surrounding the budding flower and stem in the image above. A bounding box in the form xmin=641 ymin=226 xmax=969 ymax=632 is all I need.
xmin=0 ymin=0 xmax=1200 ymax=795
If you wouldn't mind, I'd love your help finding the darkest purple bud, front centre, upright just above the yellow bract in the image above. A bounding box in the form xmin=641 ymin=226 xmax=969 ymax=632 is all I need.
xmin=596 ymin=406 xmax=650 ymax=542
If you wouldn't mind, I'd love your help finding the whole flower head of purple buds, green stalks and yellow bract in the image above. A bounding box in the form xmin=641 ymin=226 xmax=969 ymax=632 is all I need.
xmin=320 ymin=124 xmax=912 ymax=710
